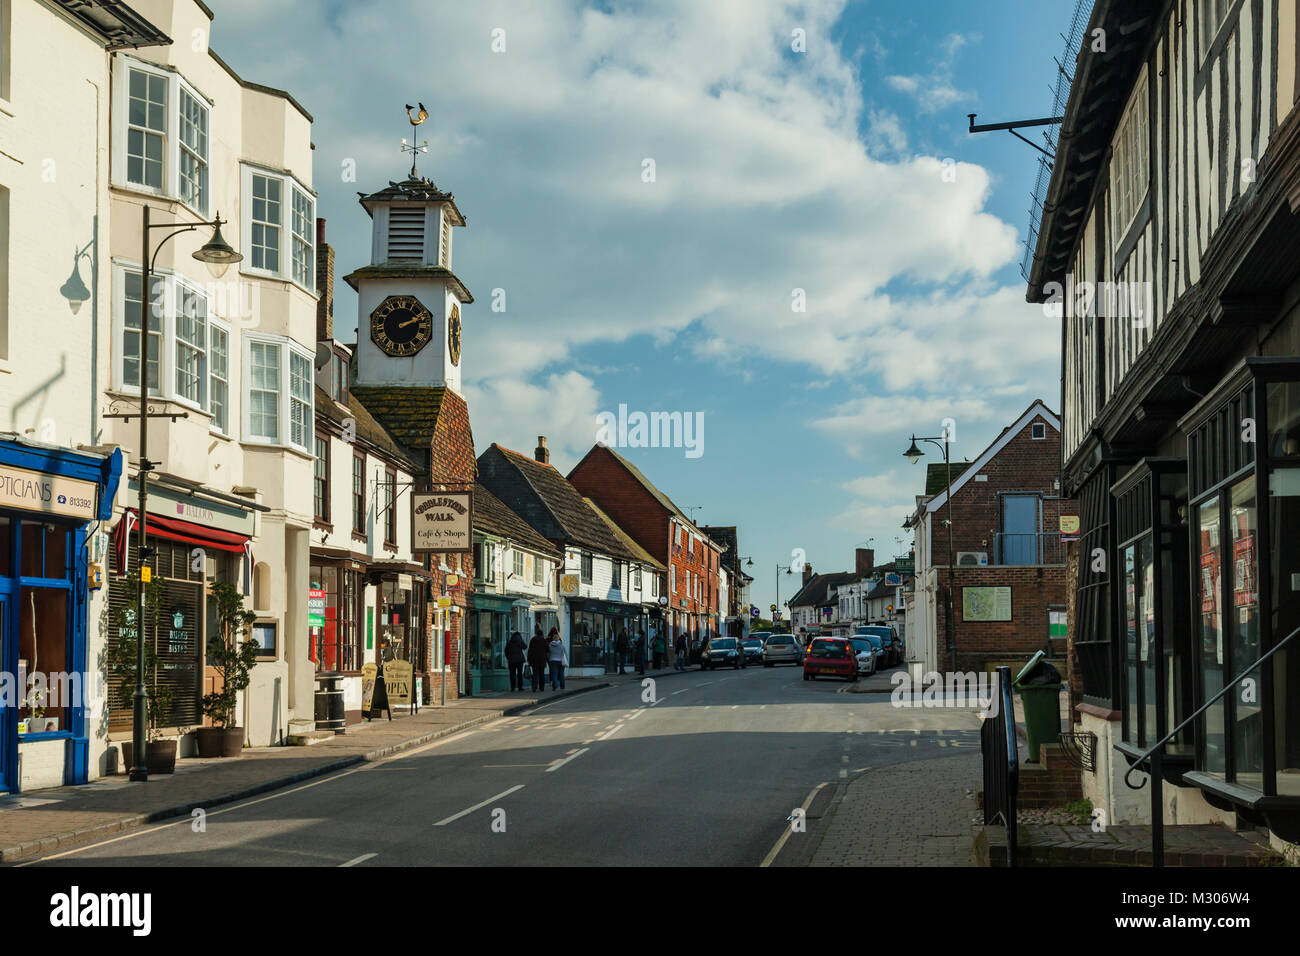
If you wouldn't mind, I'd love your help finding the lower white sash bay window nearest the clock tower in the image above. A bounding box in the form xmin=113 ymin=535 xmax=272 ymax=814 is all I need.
xmin=243 ymin=333 xmax=313 ymax=453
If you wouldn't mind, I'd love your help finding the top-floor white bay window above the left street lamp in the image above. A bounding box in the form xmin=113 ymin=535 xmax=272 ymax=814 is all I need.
xmin=113 ymin=56 xmax=211 ymax=216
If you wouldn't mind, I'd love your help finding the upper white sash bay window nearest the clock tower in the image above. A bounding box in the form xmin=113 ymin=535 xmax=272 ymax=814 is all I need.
xmin=242 ymin=165 xmax=316 ymax=295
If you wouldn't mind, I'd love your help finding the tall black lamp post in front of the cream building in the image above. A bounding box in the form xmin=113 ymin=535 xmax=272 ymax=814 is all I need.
xmin=130 ymin=203 xmax=243 ymax=782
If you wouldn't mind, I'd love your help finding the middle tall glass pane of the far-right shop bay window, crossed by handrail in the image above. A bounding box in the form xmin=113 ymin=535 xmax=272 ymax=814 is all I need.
xmin=1229 ymin=477 xmax=1264 ymax=791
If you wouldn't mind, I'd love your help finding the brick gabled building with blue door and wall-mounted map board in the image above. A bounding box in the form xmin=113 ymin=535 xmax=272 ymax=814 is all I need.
xmin=905 ymin=401 xmax=1078 ymax=675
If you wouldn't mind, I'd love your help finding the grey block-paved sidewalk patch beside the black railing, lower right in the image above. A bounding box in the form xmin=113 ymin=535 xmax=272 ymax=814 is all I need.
xmin=811 ymin=752 xmax=982 ymax=866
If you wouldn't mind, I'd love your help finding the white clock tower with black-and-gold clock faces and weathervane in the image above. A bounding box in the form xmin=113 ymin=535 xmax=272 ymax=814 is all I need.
xmin=345 ymin=140 xmax=473 ymax=395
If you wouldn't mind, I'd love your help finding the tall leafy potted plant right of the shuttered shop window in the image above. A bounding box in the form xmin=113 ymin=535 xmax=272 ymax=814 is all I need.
xmin=196 ymin=583 xmax=257 ymax=757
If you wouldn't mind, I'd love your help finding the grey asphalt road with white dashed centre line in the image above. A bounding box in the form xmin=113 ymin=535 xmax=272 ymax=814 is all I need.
xmin=25 ymin=666 xmax=979 ymax=866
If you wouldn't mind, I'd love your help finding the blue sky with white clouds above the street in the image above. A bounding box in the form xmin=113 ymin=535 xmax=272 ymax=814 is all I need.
xmin=208 ymin=0 xmax=1075 ymax=617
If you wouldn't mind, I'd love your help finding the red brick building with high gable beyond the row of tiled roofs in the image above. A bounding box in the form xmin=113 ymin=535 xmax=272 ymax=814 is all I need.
xmin=568 ymin=445 xmax=722 ymax=657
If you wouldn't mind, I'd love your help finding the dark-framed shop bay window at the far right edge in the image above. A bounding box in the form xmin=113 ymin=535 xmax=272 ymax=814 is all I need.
xmin=1179 ymin=356 xmax=1300 ymax=816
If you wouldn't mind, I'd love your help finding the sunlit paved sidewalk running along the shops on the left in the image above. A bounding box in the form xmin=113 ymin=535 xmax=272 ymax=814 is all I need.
xmin=0 ymin=678 xmax=611 ymax=862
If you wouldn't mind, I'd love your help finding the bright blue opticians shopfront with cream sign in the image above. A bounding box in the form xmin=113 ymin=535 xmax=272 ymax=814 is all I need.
xmin=0 ymin=438 xmax=122 ymax=792
